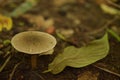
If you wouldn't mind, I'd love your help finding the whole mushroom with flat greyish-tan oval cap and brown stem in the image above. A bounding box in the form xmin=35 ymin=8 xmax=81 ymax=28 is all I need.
xmin=11 ymin=31 xmax=57 ymax=69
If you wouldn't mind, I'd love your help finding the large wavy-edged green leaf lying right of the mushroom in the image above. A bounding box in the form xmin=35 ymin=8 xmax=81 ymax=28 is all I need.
xmin=45 ymin=34 xmax=109 ymax=74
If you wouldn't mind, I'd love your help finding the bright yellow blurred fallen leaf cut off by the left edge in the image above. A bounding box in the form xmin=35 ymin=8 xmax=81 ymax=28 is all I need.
xmin=0 ymin=15 xmax=12 ymax=31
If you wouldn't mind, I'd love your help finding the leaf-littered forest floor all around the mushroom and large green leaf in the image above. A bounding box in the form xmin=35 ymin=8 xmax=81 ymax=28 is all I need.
xmin=0 ymin=0 xmax=120 ymax=80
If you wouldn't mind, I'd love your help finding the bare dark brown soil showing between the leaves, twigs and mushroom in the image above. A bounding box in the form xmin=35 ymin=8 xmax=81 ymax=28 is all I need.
xmin=0 ymin=0 xmax=120 ymax=80
